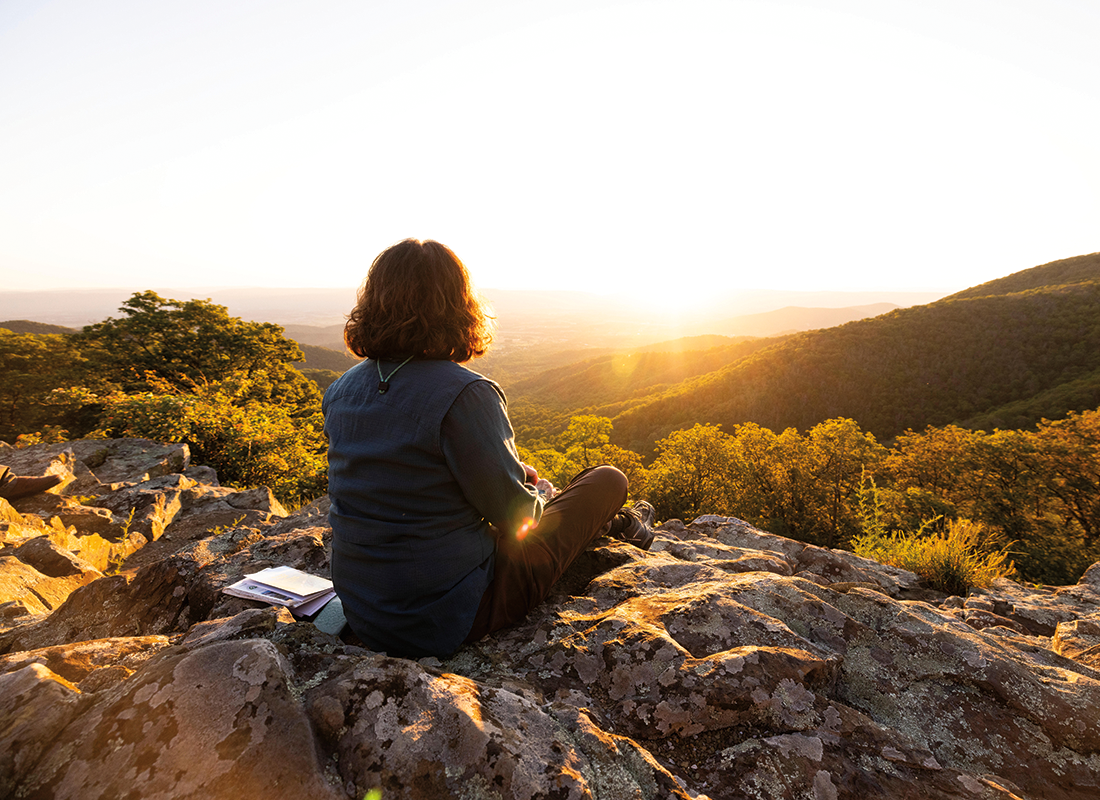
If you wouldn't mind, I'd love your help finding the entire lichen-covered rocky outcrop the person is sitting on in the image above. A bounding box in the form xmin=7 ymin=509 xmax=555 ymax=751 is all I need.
xmin=0 ymin=442 xmax=1100 ymax=800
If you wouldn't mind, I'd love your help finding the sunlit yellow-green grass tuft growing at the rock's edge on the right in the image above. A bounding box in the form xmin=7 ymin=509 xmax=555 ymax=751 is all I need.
xmin=853 ymin=519 xmax=1015 ymax=595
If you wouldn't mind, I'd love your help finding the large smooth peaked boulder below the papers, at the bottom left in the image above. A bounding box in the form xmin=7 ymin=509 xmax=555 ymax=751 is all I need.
xmin=15 ymin=639 xmax=341 ymax=800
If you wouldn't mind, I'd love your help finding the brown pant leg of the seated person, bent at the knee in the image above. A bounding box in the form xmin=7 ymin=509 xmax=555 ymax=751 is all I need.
xmin=466 ymin=465 xmax=627 ymax=642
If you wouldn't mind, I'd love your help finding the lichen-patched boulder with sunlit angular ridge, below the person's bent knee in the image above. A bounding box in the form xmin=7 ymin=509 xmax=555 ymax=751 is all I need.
xmin=527 ymin=581 xmax=837 ymax=738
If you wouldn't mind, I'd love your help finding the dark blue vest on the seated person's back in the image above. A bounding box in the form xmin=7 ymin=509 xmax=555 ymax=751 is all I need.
xmin=323 ymin=360 xmax=495 ymax=658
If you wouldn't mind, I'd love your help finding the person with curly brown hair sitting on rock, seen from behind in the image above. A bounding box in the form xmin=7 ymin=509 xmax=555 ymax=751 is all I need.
xmin=323 ymin=239 xmax=653 ymax=658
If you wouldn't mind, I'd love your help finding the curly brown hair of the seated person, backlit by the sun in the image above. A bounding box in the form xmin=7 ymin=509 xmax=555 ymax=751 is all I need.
xmin=344 ymin=239 xmax=493 ymax=363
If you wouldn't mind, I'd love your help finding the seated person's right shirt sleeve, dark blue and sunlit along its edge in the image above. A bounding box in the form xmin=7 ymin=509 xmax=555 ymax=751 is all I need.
xmin=440 ymin=381 xmax=542 ymax=534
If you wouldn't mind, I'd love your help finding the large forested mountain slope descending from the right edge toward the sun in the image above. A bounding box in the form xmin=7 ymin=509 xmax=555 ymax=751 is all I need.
xmin=509 ymin=254 xmax=1100 ymax=452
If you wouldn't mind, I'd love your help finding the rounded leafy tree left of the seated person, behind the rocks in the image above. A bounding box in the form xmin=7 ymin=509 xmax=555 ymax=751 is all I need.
xmin=66 ymin=292 xmax=327 ymax=503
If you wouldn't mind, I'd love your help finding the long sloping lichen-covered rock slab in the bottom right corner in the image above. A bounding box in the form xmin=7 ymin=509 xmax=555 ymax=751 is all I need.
xmin=834 ymin=590 xmax=1100 ymax=798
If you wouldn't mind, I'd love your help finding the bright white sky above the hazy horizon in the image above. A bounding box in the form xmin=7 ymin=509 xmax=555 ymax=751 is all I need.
xmin=0 ymin=0 xmax=1100 ymax=299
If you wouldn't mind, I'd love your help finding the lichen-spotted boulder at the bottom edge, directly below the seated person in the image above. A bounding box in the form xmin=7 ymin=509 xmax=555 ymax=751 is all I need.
xmin=308 ymin=656 xmax=690 ymax=800
